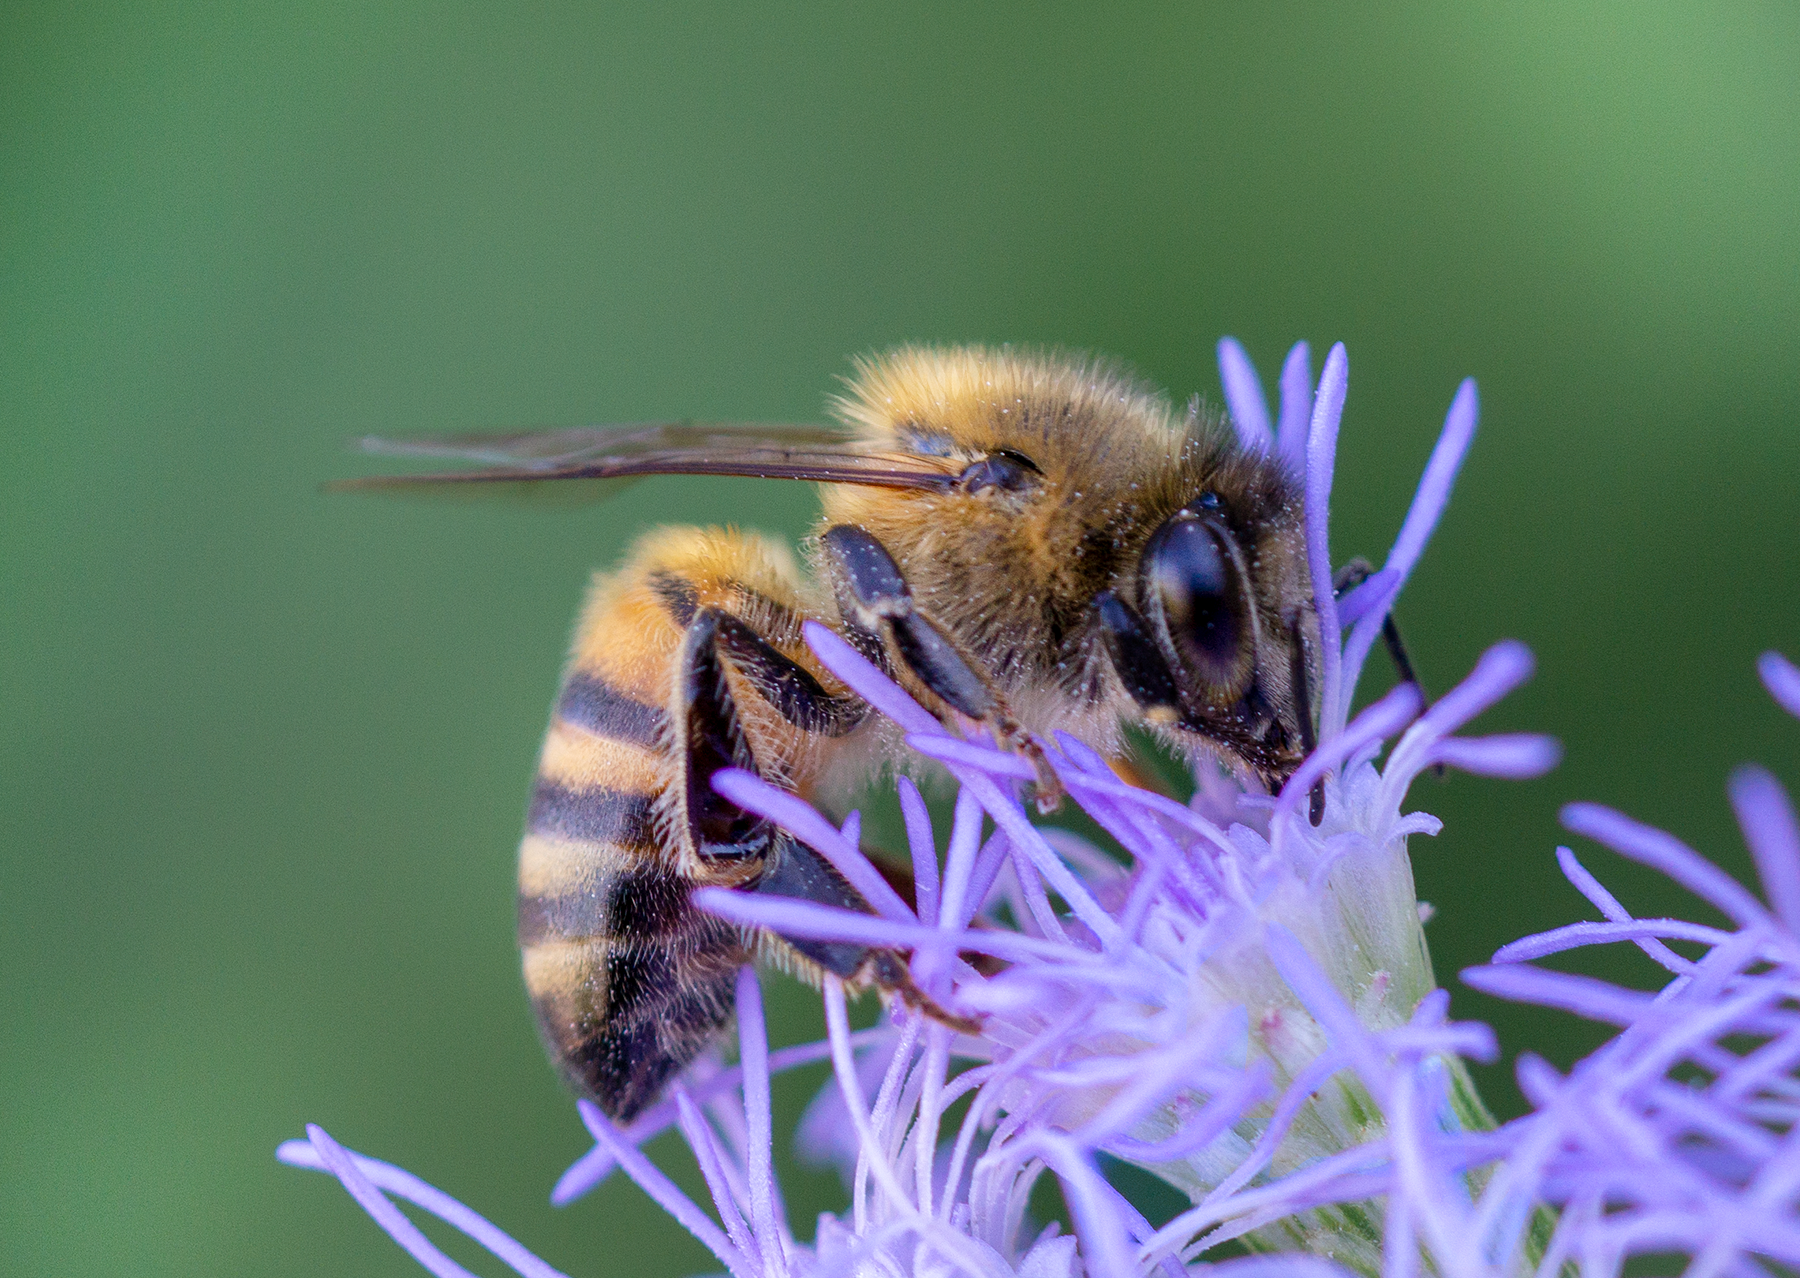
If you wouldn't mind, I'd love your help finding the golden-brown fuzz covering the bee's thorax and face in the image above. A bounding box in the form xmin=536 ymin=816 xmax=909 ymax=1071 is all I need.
xmin=821 ymin=347 xmax=1309 ymax=749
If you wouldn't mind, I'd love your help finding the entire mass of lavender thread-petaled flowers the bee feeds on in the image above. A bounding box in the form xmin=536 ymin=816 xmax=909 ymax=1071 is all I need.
xmin=281 ymin=342 xmax=1800 ymax=1278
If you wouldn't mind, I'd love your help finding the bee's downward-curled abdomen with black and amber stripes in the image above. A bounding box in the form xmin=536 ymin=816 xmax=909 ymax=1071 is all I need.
xmin=518 ymin=529 xmax=813 ymax=1121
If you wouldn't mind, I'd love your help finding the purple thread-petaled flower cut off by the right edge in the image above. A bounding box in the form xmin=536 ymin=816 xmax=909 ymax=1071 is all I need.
xmin=1463 ymin=652 xmax=1800 ymax=1274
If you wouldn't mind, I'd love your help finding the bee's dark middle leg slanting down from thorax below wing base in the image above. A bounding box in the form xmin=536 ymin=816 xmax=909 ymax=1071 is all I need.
xmin=819 ymin=524 xmax=1062 ymax=812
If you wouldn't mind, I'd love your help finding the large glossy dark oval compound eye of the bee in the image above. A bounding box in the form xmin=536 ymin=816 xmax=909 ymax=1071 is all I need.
xmin=1141 ymin=515 xmax=1247 ymax=688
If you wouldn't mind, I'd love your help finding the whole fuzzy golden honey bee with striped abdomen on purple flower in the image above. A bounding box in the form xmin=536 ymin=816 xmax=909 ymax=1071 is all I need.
xmin=349 ymin=347 xmax=1318 ymax=1121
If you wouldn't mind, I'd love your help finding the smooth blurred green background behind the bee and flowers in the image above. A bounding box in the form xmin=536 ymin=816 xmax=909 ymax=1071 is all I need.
xmin=0 ymin=0 xmax=1800 ymax=1276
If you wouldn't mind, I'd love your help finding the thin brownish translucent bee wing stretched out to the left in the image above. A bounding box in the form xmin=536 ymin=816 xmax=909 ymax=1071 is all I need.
xmin=328 ymin=421 xmax=956 ymax=497
